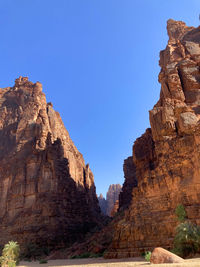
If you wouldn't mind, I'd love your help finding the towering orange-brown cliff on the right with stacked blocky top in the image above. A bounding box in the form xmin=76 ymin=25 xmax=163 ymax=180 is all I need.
xmin=105 ymin=20 xmax=200 ymax=257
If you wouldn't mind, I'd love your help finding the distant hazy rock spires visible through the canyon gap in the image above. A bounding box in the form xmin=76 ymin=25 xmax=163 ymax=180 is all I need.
xmin=98 ymin=184 xmax=122 ymax=217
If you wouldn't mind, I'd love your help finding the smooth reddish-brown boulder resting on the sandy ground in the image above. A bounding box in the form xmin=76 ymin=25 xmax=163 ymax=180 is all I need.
xmin=150 ymin=248 xmax=184 ymax=264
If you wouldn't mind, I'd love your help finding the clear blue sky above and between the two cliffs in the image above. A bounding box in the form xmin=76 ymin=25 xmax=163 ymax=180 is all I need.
xmin=0 ymin=0 xmax=200 ymax=195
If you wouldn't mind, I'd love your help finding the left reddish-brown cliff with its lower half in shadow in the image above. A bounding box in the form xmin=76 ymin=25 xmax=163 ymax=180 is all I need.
xmin=0 ymin=77 xmax=100 ymax=248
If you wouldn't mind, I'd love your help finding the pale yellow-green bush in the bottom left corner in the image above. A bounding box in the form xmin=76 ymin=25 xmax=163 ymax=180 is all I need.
xmin=0 ymin=241 xmax=20 ymax=267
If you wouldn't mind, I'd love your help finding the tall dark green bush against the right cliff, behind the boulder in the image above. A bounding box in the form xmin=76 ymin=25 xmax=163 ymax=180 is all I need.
xmin=172 ymin=205 xmax=200 ymax=257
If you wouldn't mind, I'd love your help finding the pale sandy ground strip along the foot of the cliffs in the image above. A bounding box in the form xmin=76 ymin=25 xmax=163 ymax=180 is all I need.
xmin=19 ymin=258 xmax=200 ymax=267
